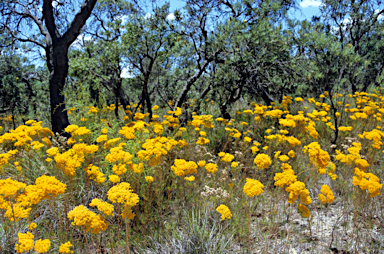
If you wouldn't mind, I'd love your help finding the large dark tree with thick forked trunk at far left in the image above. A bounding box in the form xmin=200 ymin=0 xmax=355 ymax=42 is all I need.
xmin=0 ymin=0 xmax=97 ymax=133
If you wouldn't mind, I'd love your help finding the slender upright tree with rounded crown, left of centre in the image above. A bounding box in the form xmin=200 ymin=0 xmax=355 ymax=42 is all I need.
xmin=122 ymin=4 xmax=176 ymax=119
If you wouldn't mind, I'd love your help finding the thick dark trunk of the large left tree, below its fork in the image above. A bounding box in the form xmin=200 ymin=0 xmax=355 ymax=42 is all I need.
xmin=48 ymin=42 xmax=69 ymax=136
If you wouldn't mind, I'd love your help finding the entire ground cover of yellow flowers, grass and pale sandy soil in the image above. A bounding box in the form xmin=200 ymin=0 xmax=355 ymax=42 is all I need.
xmin=0 ymin=89 xmax=384 ymax=253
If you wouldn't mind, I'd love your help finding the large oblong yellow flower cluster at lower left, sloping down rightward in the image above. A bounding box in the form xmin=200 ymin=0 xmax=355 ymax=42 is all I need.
xmin=68 ymin=205 xmax=108 ymax=234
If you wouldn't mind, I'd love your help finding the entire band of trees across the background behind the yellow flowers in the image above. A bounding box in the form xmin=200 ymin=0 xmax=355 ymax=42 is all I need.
xmin=0 ymin=0 xmax=384 ymax=132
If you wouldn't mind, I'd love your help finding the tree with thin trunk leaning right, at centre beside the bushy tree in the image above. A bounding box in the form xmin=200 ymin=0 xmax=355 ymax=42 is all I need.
xmin=166 ymin=0 xmax=226 ymax=110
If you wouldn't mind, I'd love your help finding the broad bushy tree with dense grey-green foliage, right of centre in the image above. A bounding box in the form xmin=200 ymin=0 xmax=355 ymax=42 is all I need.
xmin=202 ymin=1 xmax=299 ymax=115
